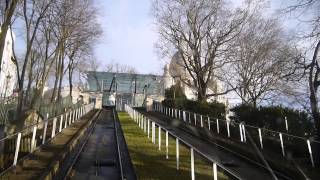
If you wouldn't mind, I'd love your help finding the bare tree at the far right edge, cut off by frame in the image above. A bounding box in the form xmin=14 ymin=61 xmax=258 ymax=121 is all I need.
xmin=283 ymin=0 xmax=320 ymax=166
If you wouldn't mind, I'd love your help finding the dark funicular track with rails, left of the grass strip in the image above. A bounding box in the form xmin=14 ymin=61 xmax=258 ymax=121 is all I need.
xmin=61 ymin=108 xmax=136 ymax=180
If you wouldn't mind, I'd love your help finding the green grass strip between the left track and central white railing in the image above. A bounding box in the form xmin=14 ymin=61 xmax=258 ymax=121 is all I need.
xmin=119 ymin=112 xmax=228 ymax=180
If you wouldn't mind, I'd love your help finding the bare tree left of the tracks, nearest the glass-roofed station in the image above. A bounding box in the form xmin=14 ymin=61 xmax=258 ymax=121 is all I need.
xmin=47 ymin=0 xmax=101 ymax=101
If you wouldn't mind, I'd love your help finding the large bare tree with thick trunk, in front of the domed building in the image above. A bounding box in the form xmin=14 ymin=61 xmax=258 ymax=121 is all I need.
xmin=153 ymin=0 xmax=257 ymax=101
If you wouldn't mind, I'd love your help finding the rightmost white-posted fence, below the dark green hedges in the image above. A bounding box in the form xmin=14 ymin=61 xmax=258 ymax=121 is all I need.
xmin=153 ymin=103 xmax=320 ymax=172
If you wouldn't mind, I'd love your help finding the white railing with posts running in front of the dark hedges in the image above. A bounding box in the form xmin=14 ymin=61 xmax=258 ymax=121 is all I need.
xmin=153 ymin=103 xmax=320 ymax=167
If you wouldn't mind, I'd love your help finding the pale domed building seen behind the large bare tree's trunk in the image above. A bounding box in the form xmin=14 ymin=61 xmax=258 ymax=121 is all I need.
xmin=163 ymin=53 xmax=228 ymax=105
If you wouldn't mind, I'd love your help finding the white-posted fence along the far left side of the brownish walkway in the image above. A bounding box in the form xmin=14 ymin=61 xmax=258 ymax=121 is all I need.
xmin=0 ymin=103 xmax=94 ymax=175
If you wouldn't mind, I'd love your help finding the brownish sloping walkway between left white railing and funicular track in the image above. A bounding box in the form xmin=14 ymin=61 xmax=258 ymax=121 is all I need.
xmin=0 ymin=110 xmax=97 ymax=180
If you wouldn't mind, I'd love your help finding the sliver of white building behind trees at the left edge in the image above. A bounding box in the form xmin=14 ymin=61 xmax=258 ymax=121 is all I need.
xmin=0 ymin=30 xmax=17 ymax=97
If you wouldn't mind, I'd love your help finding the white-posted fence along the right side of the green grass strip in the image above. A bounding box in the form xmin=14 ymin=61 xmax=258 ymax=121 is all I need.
xmin=125 ymin=105 xmax=241 ymax=180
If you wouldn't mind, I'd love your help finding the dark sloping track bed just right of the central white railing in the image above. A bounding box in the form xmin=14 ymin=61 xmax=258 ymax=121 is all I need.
xmin=140 ymin=111 xmax=282 ymax=180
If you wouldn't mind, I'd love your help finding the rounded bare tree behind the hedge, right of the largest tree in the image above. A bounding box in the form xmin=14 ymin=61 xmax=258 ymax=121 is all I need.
xmin=225 ymin=16 xmax=296 ymax=108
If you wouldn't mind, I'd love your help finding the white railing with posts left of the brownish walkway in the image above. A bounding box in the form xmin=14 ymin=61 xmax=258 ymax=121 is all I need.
xmin=0 ymin=103 xmax=94 ymax=175
